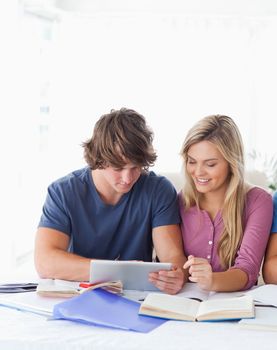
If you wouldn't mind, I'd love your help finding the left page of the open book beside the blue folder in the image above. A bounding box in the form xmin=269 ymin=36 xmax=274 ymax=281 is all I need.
xmin=142 ymin=293 xmax=200 ymax=319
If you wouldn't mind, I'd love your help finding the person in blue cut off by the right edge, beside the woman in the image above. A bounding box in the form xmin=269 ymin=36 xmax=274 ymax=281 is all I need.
xmin=263 ymin=192 xmax=277 ymax=284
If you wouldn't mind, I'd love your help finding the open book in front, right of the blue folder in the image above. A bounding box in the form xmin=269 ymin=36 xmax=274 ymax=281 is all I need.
xmin=139 ymin=293 xmax=255 ymax=321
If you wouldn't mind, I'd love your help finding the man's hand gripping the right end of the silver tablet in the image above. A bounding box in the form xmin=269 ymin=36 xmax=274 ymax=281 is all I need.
xmin=149 ymin=265 xmax=185 ymax=294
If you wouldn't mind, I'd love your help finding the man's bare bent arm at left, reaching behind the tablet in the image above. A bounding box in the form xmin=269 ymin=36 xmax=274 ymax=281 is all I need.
xmin=35 ymin=227 xmax=90 ymax=281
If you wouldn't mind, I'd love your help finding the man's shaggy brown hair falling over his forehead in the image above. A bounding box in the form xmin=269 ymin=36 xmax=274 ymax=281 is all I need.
xmin=83 ymin=108 xmax=157 ymax=170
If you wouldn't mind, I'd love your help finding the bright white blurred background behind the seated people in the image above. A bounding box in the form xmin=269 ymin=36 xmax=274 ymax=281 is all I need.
xmin=0 ymin=0 xmax=277 ymax=278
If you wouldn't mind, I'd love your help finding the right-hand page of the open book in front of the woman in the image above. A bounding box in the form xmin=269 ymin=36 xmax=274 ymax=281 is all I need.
xmin=197 ymin=296 xmax=254 ymax=319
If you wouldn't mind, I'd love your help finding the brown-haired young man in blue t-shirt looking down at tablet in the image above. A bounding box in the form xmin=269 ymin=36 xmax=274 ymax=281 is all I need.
xmin=35 ymin=108 xmax=186 ymax=294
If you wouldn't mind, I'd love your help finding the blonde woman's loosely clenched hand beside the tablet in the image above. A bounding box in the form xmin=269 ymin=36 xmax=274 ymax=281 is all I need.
xmin=183 ymin=255 xmax=213 ymax=291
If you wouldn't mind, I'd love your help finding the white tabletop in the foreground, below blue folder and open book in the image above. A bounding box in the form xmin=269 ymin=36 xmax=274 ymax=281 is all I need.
xmin=0 ymin=300 xmax=277 ymax=350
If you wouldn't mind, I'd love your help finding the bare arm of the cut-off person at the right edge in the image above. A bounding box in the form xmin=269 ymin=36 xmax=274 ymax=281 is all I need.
xmin=263 ymin=232 xmax=277 ymax=284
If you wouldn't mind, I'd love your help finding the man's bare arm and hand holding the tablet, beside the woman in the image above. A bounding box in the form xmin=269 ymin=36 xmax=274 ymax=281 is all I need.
xmin=149 ymin=225 xmax=188 ymax=294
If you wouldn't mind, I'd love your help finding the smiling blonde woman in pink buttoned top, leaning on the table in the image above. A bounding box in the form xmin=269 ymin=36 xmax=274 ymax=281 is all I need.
xmin=179 ymin=115 xmax=273 ymax=292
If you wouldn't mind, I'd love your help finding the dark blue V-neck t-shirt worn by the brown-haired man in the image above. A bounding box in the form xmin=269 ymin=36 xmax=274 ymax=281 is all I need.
xmin=39 ymin=167 xmax=180 ymax=261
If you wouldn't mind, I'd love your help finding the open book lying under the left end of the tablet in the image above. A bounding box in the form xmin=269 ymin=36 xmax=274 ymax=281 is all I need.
xmin=37 ymin=279 xmax=123 ymax=298
